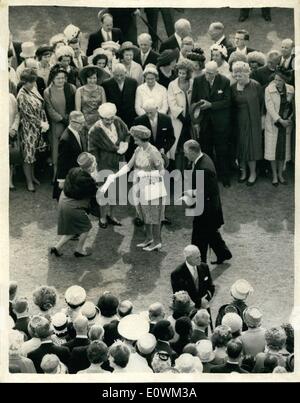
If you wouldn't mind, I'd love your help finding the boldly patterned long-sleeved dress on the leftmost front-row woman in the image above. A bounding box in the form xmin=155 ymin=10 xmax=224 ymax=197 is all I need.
xmin=17 ymin=87 xmax=46 ymax=164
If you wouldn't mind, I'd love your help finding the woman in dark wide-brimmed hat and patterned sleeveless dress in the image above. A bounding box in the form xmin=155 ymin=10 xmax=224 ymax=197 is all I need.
xmin=75 ymin=66 xmax=109 ymax=129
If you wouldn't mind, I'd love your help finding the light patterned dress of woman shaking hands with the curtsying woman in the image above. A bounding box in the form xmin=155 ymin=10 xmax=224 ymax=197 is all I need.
xmin=133 ymin=143 xmax=164 ymax=224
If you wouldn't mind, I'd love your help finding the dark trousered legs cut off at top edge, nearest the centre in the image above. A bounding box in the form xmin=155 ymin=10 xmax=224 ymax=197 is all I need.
xmin=145 ymin=8 xmax=174 ymax=49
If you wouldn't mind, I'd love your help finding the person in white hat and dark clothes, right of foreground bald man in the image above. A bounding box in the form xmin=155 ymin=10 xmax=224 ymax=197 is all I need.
xmin=216 ymin=279 xmax=253 ymax=330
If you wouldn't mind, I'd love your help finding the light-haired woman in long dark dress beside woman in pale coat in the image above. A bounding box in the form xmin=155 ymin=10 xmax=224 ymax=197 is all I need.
xmin=231 ymin=62 xmax=263 ymax=186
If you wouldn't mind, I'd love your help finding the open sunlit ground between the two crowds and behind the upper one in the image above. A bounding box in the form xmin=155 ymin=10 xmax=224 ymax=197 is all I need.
xmin=9 ymin=7 xmax=294 ymax=326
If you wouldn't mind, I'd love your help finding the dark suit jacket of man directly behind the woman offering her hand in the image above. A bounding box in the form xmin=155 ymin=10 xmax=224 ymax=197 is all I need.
xmin=134 ymin=113 xmax=175 ymax=153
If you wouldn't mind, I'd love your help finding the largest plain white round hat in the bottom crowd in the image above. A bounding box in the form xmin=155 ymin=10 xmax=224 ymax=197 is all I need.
xmin=118 ymin=314 xmax=150 ymax=340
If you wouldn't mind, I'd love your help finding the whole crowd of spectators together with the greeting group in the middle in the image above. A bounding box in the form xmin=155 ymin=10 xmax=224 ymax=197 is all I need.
xmin=8 ymin=9 xmax=295 ymax=373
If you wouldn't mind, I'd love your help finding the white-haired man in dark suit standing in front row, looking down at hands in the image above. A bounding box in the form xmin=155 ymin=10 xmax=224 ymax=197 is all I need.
xmin=191 ymin=61 xmax=231 ymax=187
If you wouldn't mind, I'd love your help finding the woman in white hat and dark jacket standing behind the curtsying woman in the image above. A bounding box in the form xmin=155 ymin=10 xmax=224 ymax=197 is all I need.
xmin=89 ymin=102 xmax=130 ymax=229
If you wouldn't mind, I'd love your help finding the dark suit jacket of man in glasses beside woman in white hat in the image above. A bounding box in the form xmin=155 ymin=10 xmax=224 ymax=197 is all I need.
xmin=57 ymin=127 xmax=86 ymax=179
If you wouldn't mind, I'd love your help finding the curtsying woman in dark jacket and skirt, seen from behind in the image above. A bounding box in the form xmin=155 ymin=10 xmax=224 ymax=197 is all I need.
xmin=50 ymin=152 xmax=97 ymax=257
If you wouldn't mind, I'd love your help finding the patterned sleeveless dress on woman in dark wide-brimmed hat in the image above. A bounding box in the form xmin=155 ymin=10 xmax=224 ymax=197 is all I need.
xmin=78 ymin=85 xmax=106 ymax=129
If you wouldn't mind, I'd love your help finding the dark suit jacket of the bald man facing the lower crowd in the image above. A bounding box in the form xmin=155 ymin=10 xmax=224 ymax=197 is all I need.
xmin=171 ymin=263 xmax=215 ymax=308
